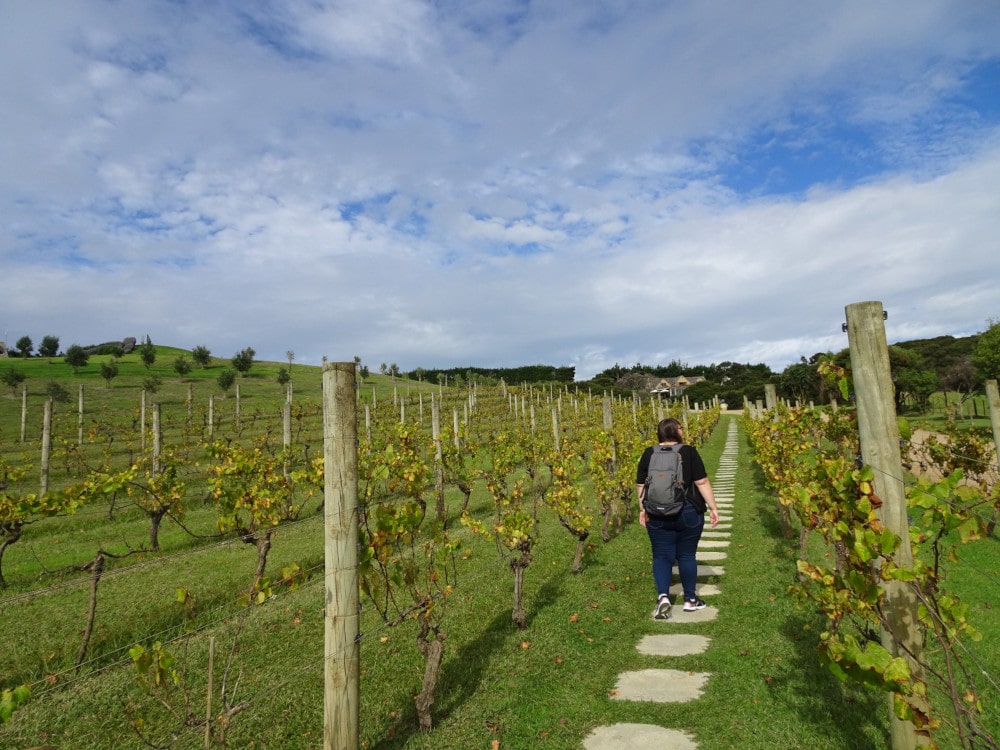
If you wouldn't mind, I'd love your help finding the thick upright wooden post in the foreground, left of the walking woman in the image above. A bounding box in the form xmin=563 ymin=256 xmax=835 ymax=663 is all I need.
xmin=323 ymin=362 xmax=360 ymax=750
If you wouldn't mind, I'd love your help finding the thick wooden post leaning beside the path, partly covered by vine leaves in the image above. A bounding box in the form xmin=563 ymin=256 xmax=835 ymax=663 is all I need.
xmin=846 ymin=302 xmax=923 ymax=750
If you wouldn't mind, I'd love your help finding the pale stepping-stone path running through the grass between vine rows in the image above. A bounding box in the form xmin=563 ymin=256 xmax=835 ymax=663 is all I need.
xmin=583 ymin=420 xmax=739 ymax=750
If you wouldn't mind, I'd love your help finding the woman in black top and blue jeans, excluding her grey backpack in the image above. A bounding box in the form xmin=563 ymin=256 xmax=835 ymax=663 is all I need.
xmin=635 ymin=418 xmax=719 ymax=620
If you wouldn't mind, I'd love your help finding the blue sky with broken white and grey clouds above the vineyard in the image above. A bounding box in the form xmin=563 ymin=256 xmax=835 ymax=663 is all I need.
xmin=0 ymin=0 xmax=1000 ymax=378
